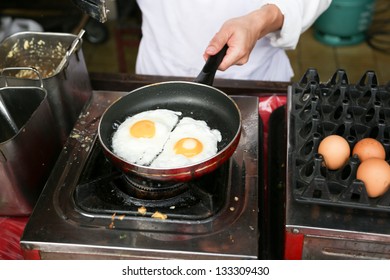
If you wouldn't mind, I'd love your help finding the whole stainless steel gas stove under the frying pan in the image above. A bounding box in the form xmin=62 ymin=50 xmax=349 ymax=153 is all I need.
xmin=21 ymin=90 xmax=262 ymax=259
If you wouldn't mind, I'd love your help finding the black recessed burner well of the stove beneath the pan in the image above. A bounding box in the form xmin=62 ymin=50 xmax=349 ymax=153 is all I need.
xmin=73 ymin=144 xmax=230 ymax=220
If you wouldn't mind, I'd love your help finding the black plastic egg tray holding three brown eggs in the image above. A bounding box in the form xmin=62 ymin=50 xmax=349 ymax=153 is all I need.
xmin=287 ymin=68 xmax=390 ymax=212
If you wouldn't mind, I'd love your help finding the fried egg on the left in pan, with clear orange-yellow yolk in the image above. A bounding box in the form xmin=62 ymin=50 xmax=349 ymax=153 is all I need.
xmin=112 ymin=109 xmax=181 ymax=165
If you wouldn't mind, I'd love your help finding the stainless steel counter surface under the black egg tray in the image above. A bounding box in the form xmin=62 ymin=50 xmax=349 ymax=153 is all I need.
xmin=285 ymin=84 xmax=390 ymax=258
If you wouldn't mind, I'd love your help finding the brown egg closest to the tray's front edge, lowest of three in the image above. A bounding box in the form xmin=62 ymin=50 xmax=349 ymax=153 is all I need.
xmin=356 ymin=158 xmax=390 ymax=197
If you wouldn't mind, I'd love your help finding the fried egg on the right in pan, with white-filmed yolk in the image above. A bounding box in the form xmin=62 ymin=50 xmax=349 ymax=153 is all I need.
xmin=151 ymin=117 xmax=222 ymax=168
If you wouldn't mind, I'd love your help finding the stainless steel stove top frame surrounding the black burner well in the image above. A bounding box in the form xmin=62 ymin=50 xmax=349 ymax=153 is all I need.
xmin=21 ymin=91 xmax=259 ymax=259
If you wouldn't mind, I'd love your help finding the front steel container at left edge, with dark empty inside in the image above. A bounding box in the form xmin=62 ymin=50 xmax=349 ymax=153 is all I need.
xmin=0 ymin=74 xmax=61 ymax=216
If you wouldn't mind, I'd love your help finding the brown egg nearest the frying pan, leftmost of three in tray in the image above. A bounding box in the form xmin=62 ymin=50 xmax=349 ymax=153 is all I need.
xmin=318 ymin=135 xmax=351 ymax=170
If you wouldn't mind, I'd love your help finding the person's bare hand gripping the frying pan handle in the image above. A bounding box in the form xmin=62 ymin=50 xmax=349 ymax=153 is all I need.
xmin=203 ymin=4 xmax=284 ymax=71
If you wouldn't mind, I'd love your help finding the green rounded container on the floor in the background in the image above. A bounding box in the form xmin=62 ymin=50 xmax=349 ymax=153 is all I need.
xmin=314 ymin=0 xmax=376 ymax=46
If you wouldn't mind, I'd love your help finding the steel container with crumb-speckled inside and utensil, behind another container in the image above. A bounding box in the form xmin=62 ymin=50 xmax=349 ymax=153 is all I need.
xmin=0 ymin=32 xmax=92 ymax=143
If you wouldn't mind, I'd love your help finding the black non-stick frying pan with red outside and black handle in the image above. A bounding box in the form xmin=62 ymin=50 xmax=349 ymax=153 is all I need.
xmin=98 ymin=46 xmax=241 ymax=182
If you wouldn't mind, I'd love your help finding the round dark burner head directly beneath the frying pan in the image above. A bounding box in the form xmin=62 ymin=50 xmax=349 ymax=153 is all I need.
xmin=120 ymin=175 xmax=188 ymax=200
